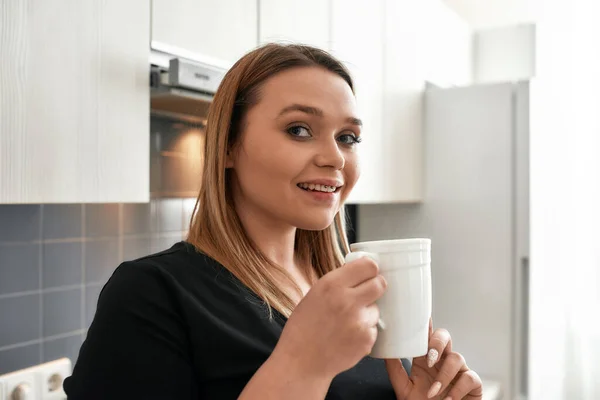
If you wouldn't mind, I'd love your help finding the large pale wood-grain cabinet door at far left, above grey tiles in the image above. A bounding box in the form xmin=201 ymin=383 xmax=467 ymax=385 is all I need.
xmin=0 ymin=0 xmax=150 ymax=203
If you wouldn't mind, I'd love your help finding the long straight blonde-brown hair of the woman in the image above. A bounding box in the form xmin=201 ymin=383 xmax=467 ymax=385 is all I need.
xmin=187 ymin=44 xmax=354 ymax=317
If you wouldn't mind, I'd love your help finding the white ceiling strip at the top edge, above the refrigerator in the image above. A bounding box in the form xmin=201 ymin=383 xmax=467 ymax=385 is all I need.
xmin=443 ymin=0 xmax=543 ymax=30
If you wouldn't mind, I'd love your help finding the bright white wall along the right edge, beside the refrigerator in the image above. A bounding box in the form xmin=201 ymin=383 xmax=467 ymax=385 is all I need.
xmin=530 ymin=0 xmax=600 ymax=400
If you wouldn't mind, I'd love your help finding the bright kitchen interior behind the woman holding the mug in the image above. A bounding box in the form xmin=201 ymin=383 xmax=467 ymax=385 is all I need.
xmin=0 ymin=0 xmax=600 ymax=400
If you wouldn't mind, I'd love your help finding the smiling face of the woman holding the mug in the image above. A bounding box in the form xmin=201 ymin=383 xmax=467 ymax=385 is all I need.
xmin=228 ymin=67 xmax=361 ymax=230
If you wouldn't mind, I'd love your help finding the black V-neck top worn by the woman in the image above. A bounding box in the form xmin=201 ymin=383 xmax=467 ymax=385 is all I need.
xmin=64 ymin=242 xmax=406 ymax=400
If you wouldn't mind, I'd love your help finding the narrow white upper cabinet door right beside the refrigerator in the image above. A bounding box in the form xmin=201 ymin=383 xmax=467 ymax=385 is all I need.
xmin=379 ymin=0 xmax=427 ymax=203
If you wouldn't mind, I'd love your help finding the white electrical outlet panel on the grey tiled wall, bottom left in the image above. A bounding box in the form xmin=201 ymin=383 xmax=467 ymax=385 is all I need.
xmin=0 ymin=358 xmax=72 ymax=400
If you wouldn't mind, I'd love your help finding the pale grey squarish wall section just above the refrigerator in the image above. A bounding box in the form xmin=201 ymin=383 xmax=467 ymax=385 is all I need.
xmin=473 ymin=24 xmax=535 ymax=83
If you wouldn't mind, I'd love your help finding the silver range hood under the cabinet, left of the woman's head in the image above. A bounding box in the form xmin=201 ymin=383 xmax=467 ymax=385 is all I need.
xmin=150 ymin=49 xmax=227 ymax=124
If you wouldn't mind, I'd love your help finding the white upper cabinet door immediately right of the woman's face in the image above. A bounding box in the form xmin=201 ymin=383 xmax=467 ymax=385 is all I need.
xmin=331 ymin=0 xmax=389 ymax=203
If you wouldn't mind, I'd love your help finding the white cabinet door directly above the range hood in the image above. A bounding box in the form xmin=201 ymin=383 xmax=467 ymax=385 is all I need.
xmin=152 ymin=0 xmax=258 ymax=64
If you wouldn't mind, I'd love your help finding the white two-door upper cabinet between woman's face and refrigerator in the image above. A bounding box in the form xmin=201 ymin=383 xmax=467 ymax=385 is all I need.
xmin=331 ymin=0 xmax=427 ymax=204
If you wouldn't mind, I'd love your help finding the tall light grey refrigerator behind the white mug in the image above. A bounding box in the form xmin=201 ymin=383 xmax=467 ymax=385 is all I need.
xmin=358 ymin=82 xmax=529 ymax=399
